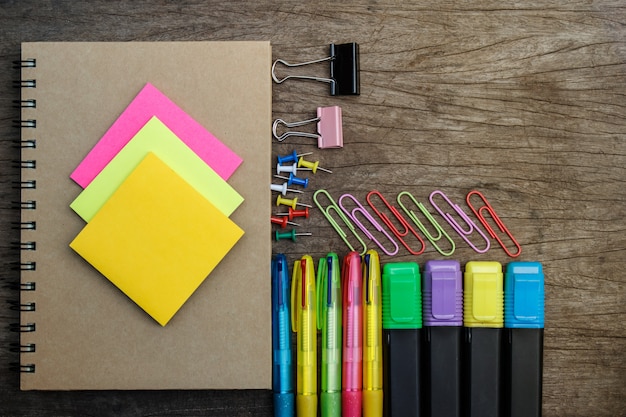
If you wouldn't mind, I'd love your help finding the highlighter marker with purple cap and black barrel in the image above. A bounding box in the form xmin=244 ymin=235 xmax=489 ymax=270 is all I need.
xmin=422 ymin=260 xmax=463 ymax=417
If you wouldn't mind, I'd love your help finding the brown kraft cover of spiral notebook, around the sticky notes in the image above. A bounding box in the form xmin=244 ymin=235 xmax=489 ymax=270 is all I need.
xmin=19 ymin=42 xmax=272 ymax=390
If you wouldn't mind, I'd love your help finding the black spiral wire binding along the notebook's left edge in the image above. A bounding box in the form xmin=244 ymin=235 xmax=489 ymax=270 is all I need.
xmin=9 ymin=59 xmax=37 ymax=373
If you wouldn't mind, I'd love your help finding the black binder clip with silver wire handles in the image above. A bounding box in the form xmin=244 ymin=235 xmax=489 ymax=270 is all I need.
xmin=272 ymin=42 xmax=361 ymax=96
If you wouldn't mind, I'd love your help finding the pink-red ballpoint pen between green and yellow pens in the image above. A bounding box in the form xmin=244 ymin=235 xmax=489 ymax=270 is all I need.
xmin=341 ymin=251 xmax=363 ymax=417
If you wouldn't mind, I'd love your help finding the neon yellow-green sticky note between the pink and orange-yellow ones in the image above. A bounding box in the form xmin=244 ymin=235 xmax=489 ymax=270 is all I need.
xmin=70 ymin=117 xmax=243 ymax=222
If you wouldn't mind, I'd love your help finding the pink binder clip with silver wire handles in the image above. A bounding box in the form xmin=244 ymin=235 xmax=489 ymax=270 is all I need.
xmin=272 ymin=106 xmax=343 ymax=149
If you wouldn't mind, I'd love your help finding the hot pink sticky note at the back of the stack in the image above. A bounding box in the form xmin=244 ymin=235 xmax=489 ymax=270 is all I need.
xmin=70 ymin=83 xmax=242 ymax=188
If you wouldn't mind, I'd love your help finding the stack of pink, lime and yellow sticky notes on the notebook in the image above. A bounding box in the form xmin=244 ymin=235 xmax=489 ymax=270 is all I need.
xmin=70 ymin=84 xmax=244 ymax=326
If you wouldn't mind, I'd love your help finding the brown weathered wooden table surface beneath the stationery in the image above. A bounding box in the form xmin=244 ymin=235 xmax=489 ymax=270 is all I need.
xmin=0 ymin=0 xmax=626 ymax=416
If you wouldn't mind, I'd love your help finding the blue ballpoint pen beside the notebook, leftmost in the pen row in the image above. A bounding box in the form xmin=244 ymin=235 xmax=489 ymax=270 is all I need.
xmin=272 ymin=254 xmax=295 ymax=417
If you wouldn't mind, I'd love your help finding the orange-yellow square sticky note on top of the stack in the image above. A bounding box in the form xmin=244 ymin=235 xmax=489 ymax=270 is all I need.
xmin=70 ymin=153 xmax=244 ymax=326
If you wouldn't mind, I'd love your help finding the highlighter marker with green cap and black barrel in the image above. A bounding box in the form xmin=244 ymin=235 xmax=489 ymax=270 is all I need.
xmin=382 ymin=262 xmax=422 ymax=417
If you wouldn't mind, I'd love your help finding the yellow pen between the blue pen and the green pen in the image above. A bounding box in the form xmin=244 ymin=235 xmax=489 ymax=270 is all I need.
xmin=291 ymin=255 xmax=317 ymax=417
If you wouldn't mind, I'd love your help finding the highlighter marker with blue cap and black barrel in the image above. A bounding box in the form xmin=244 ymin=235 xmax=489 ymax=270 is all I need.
xmin=503 ymin=262 xmax=544 ymax=417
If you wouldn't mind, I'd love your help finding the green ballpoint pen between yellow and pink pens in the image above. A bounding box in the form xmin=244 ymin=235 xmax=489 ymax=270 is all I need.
xmin=317 ymin=253 xmax=342 ymax=417
